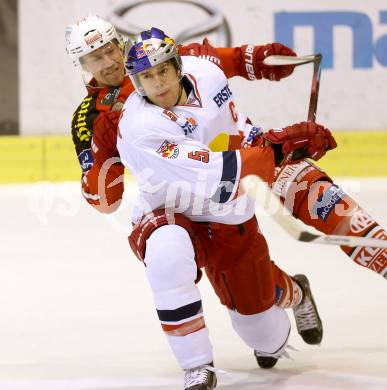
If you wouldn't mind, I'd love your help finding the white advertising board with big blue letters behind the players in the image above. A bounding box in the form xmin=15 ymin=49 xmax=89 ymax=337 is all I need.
xmin=19 ymin=0 xmax=387 ymax=134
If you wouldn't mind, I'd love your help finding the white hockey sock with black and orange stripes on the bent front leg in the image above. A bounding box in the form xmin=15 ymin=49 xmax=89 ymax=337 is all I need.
xmin=145 ymin=225 xmax=213 ymax=369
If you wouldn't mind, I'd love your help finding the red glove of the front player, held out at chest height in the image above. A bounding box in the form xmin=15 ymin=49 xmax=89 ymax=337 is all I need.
xmin=263 ymin=122 xmax=337 ymax=165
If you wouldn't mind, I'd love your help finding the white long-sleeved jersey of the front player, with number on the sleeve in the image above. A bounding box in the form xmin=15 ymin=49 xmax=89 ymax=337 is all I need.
xmin=117 ymin=57 xmax=254 ymax=224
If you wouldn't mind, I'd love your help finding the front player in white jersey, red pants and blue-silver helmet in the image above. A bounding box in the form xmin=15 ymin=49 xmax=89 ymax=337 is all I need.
xmin=117 ymin=28 xmax=329 ymax=390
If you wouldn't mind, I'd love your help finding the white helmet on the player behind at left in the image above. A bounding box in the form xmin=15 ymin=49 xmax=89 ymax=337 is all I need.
xmin=65 ymin=14 xmax=124 ymax=66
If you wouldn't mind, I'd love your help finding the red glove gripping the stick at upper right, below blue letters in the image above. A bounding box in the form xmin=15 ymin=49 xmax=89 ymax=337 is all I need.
xmin=241 ymin=42 xmax=296 ymax=81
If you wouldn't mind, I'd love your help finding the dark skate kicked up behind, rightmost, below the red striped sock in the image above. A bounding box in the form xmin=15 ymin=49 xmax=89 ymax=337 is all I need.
xmin=293 ymin=275 xmax=323 ymax=344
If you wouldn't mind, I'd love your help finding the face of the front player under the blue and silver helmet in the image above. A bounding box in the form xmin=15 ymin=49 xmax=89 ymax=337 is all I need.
xmin=138 ymin=61 xmax=181 ymax=109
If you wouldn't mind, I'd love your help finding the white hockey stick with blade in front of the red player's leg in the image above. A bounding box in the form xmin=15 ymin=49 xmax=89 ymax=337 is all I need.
xmin=241 ymin=176 xmax=387 ymax=248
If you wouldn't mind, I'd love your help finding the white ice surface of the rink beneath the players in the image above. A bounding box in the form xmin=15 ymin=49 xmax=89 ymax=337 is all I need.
xmin=0 ymin=179 xmax=387 ymax=390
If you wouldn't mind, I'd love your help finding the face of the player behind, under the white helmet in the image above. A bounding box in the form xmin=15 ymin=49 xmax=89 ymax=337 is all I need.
xmin=81 ymin=42 xmax=125 ymax=87
